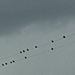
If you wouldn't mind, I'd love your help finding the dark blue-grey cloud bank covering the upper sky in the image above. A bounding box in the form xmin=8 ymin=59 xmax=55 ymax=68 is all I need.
xmin=0 ymin=0 xmax=75 ymax=36
